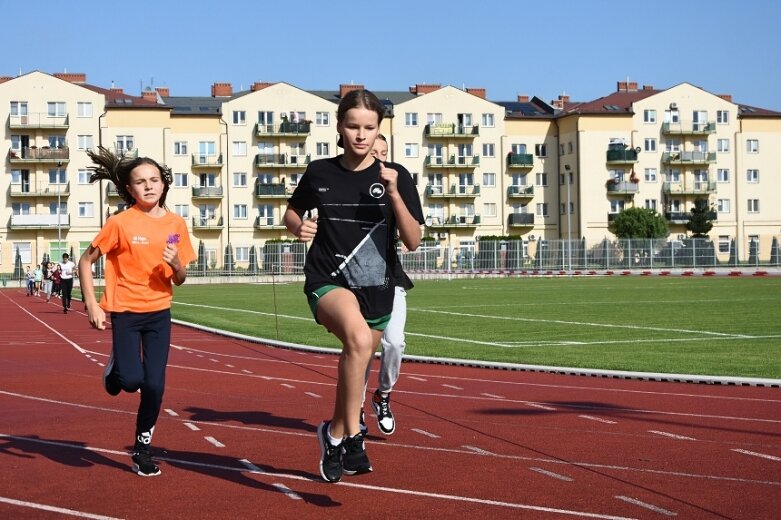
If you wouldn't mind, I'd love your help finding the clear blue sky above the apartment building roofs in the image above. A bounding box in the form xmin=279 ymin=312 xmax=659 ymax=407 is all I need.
xmin=6 ymin=0 xmax=781 ymax=111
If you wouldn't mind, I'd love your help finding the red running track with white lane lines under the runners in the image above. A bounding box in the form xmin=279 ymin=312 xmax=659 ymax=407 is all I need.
xmin=0 ymin=289 xmax=781 ymax=520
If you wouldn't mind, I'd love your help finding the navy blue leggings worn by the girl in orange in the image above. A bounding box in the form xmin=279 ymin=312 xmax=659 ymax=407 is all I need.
xmin=111 ymin=309 xmax=171 ymax=435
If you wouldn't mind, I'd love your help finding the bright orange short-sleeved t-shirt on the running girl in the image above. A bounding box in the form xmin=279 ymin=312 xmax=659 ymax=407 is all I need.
xmin=92 ymin=206 xmax=196 ymax=312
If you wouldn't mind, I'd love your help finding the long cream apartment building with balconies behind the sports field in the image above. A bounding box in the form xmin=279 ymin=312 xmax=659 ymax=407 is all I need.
xmin=0 ymin=72 xmax=781 ymax=272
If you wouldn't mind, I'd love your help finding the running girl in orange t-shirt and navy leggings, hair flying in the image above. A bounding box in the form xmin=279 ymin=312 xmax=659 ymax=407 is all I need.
xmin=79 ymin=147 xmax=195 ymax=477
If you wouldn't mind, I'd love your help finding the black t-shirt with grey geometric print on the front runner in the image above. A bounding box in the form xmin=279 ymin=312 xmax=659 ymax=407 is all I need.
xmin=288 ymin=157 xmax=423 ymax=319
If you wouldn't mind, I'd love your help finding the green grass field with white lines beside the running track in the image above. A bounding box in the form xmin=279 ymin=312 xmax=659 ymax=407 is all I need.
xmin=160 ymin=276 xmax=781 ymax=379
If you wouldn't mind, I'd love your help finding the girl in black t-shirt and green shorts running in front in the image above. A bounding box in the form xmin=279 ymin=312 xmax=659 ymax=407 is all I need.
xmin=284 ymin=90 xmax=422 ymax=482
